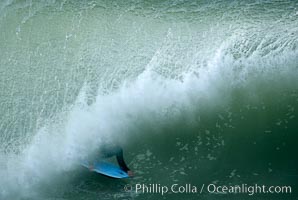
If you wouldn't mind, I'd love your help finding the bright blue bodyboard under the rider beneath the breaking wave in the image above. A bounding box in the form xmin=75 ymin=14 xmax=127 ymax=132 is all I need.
xmin=82 ymin=161 xmax=129 ymax=178
